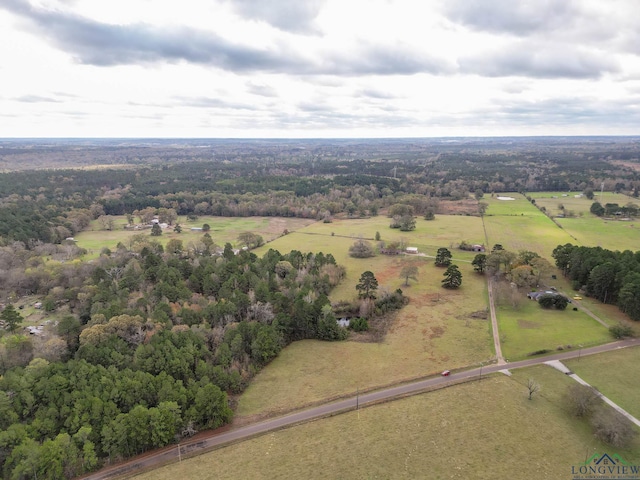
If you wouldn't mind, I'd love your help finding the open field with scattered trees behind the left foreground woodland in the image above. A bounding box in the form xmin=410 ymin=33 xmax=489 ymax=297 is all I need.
xmin=75 ymin=216 xmax=315 ymax=258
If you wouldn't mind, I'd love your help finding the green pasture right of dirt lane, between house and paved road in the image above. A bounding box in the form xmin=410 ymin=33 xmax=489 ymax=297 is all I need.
xmin=496 ymin=297 xmax=612 ymax=360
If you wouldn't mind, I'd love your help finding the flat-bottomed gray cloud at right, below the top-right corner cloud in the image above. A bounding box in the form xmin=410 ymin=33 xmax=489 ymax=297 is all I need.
xmin=459 ymin=42 xmax=620 ymax=78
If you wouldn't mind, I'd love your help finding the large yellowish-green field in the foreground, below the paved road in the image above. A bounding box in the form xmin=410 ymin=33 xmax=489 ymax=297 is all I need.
xmin=135 ymin=366 xmax=640 ymax=480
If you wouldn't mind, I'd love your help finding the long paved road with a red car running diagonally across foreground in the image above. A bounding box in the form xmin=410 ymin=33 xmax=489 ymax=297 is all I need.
xmin=84 ymin=338 xmax=640 ymax=480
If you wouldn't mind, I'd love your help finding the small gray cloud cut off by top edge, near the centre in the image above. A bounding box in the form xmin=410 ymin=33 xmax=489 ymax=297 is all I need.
xmin=227 ymin=0 xmax=324 ymax=33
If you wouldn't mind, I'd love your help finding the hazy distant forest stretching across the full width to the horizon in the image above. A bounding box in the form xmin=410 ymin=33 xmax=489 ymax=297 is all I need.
xmin=0 ymin=137 xmax=640 ymax=248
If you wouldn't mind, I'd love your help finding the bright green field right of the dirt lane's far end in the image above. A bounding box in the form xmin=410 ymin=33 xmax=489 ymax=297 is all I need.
xmin=482 ymin=193 xmax=575 ymax=261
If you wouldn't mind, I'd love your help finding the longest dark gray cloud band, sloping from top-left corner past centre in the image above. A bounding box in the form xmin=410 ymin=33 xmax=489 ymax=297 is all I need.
xmin=0 ymin=0 xmax=451 ymax=75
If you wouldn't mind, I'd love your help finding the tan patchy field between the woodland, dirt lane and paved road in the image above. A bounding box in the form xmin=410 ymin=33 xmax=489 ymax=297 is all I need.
xmin=237 ymin=257 xmax=493 ymax=416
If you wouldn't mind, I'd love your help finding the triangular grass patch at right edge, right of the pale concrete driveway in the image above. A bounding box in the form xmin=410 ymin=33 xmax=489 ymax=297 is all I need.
xmin=565 ymin=348 xmax=640 ymax=418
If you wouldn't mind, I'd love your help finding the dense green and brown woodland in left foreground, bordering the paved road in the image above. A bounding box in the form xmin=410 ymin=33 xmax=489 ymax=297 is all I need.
xmin=0 ymin=235 xmax=405 ymax=478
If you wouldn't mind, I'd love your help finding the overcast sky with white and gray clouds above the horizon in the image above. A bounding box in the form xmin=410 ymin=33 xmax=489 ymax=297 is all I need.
xmin=0 ymin=0 xmax=640 ymax=137
